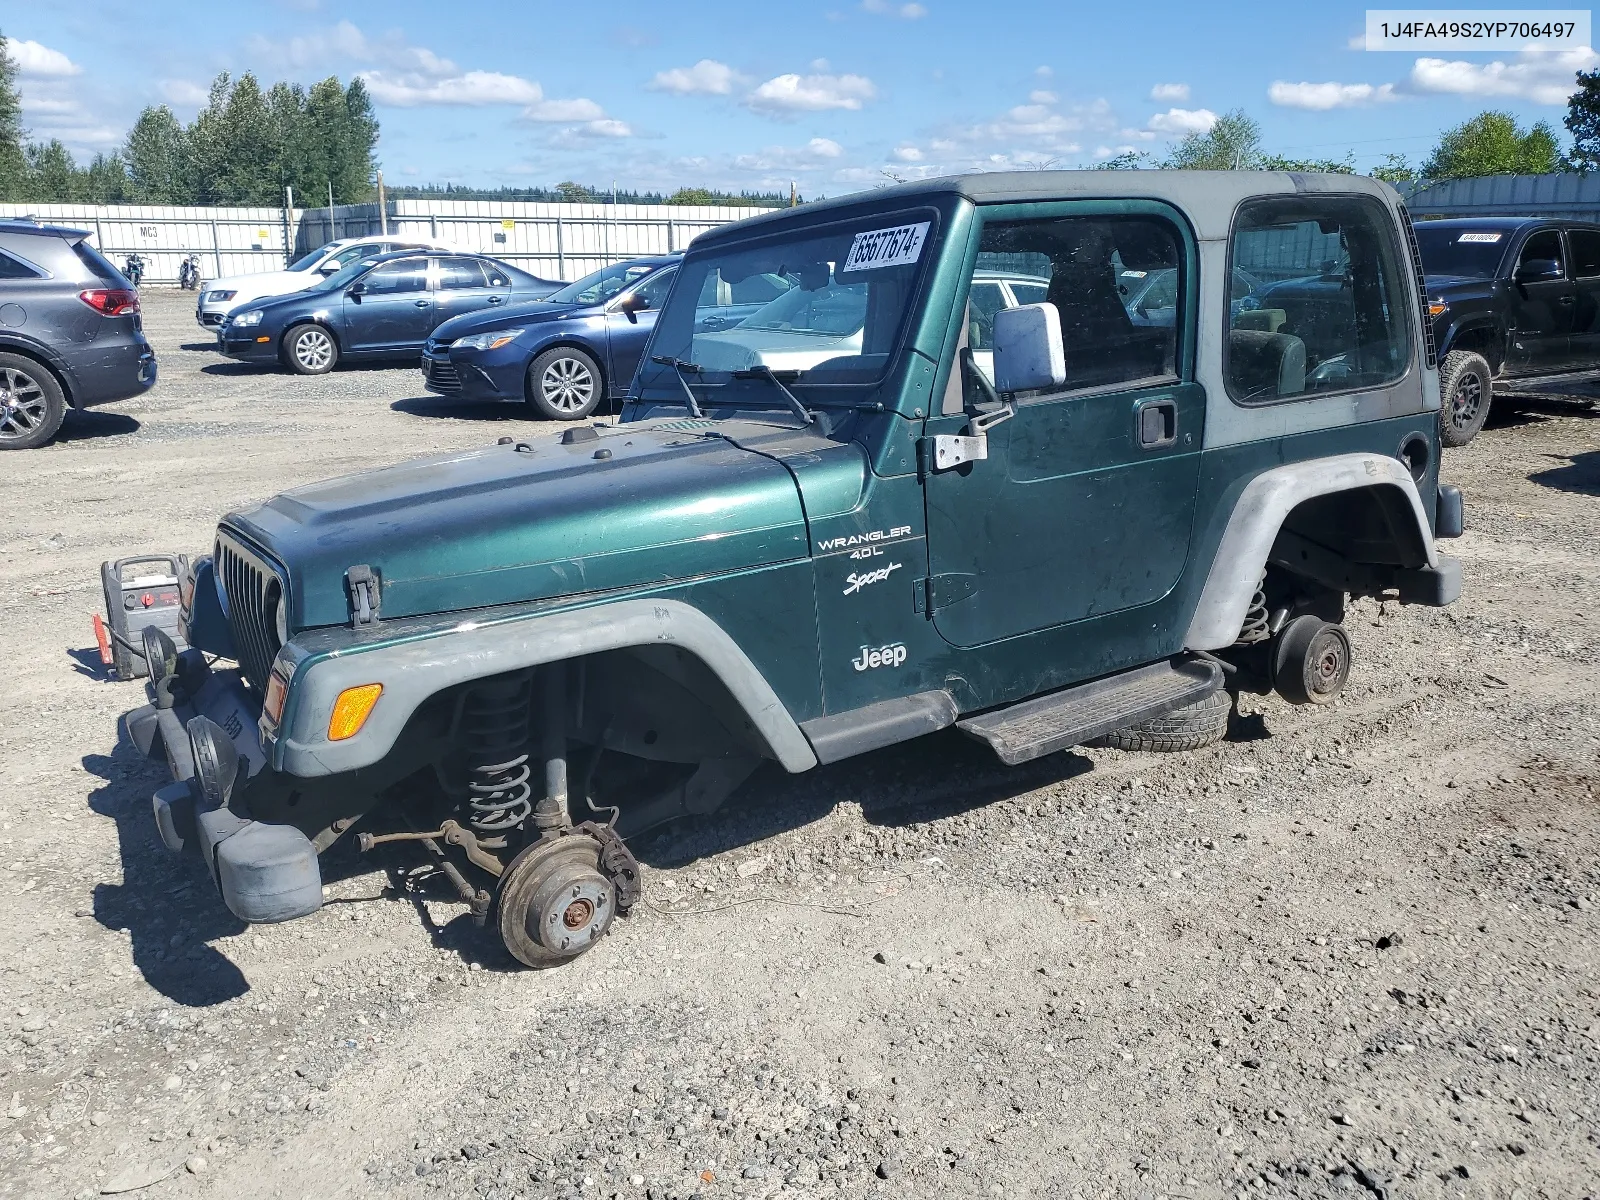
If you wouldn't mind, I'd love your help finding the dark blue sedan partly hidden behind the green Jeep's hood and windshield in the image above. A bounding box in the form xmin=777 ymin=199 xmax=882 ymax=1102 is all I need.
xmin=422 ymin=254 xmax=694 ymax=421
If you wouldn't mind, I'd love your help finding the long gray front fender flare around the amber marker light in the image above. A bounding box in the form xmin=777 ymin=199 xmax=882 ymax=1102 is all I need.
xmin=272 ymin=600 xmax=816 ymax=778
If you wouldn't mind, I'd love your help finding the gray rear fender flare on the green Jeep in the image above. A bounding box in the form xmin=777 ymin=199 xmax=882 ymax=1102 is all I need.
xmin=1184 ymin=454 xmax=1438 ymax=650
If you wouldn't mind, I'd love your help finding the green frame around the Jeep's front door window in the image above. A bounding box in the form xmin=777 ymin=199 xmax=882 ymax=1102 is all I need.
xmin=941 ymin=200 xmax=1200 ymax=416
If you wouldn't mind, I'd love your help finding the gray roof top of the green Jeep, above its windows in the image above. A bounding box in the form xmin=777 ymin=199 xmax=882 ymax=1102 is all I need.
xmin=694 ymin=170 xmax=1400 ymax=248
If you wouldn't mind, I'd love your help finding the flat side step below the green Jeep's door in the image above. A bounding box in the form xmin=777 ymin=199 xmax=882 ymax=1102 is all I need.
xmin=955 ymin=658 xmax=1222 ymax=766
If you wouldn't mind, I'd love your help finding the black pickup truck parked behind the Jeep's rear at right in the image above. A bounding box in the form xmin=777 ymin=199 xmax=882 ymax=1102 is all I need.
xmin=1414 ymin=216 xmax=1600 ymax=446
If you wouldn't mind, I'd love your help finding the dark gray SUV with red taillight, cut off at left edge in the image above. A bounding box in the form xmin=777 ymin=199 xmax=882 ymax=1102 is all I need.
xmin=0 ymin=221 xmax=155 ymax=450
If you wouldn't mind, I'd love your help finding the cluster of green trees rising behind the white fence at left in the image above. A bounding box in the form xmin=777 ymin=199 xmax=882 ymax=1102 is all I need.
xmin=0 ymin=35 xmax=378 ymax=206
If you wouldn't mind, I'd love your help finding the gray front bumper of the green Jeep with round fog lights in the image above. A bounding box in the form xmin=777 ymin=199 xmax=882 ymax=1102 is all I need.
xmin=122 ymin=650 xmax=322 ymax=923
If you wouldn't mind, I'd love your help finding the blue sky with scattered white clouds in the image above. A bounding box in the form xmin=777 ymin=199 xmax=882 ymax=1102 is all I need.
xmin=0 ymin=0 xmax=1600 ymax=195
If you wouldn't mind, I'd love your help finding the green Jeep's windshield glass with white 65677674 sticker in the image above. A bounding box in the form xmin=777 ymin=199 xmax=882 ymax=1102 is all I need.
xmin=651 ymin=210 xmax=936 ymax=386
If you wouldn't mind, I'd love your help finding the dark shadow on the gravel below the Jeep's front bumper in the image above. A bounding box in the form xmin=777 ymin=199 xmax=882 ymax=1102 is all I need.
xmin=83 ymin=739 xmax=250 ymax=1008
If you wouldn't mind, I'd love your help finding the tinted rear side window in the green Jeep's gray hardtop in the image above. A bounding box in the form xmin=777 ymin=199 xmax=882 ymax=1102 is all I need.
xmin=1222 ymin=197 xmax=1411 ymax=405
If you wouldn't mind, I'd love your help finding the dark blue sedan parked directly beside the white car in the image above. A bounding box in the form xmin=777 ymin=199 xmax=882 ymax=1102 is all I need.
xmin=216 ymin=250 xmax=562 ymax=374
